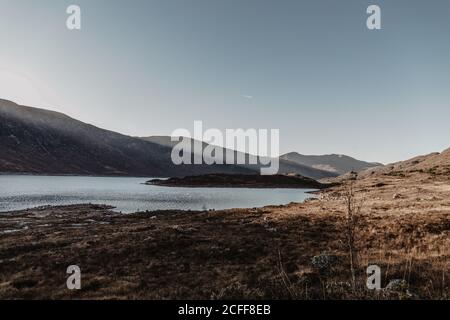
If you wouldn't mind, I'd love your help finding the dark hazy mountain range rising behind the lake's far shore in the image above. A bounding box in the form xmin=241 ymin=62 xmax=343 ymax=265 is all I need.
xmin=0 ymin=99 xmax=377 ymax=179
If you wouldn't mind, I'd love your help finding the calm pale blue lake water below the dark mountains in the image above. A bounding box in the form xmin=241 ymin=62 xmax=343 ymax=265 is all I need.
xmin=0 ymin=175 xmax=313 ymax=213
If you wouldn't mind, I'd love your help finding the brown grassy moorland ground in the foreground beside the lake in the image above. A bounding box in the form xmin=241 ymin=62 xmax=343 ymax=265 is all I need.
xmin=0 ymin=171 xmax=450 ymax=299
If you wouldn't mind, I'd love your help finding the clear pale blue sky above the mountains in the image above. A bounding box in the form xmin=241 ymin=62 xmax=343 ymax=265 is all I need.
xmin=0 ymin=0 xmax=450 ymax=162
